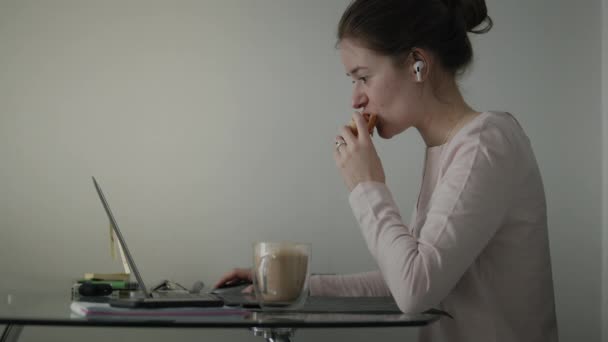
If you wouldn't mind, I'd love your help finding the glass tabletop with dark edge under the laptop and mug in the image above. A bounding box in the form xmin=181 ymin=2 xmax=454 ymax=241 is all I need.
xmin=0 ymin=291 xmax=441 ymax=342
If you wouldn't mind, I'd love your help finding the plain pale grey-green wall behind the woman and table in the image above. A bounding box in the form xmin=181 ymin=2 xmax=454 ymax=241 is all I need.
xmin=0 ymin=0 xmax=608 ymax=341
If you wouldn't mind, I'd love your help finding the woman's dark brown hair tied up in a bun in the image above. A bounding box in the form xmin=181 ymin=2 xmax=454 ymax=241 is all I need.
xmin=338 ymin=0 xmax=493 ymax=74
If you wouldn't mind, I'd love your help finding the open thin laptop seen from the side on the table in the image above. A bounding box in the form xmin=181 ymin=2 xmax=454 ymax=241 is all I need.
xmin=93 ymin=177 xmax=224 ymax=308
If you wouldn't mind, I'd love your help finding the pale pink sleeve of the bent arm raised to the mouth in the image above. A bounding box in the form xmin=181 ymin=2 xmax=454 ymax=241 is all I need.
xmin=349 ymin=119 xmax=517 ymax=313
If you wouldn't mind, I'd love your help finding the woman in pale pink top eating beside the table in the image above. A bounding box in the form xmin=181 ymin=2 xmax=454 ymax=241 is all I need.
xmin=218 ymin=0 xmax=557 ymax=341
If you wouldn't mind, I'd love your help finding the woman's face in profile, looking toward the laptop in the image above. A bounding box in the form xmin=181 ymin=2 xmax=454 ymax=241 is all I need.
xmin=339 ymin=39 xmax=419 ymax=139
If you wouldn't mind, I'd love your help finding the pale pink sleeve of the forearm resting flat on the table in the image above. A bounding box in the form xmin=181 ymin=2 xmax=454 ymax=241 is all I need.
xmin=309 ymin=271 xmax=391 ymax=297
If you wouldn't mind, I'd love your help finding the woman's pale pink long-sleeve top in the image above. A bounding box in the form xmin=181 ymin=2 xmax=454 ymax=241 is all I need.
xmin=310 ymin=112 xmax=557 ymax=342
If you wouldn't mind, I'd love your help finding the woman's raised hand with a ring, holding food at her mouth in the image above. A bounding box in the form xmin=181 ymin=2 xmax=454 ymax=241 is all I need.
xmin=334 ymin=113 xmax=385 ymax=191
